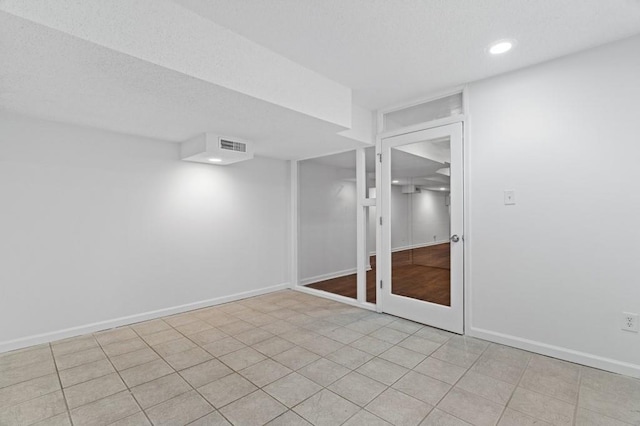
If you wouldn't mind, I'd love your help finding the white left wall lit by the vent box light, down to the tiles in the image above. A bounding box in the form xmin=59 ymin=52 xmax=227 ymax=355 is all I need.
xmin=0 ymin=113 xmax=289 ymax=352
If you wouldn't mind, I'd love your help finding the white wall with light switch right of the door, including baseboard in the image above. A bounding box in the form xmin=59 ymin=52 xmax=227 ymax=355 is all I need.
xmin=466 ymin=37 xmax=640 ymax=377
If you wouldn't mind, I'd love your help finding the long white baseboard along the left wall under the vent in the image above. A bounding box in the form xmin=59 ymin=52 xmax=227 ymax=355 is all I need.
xmin=0 ymin=283 xmax=290 ymax=353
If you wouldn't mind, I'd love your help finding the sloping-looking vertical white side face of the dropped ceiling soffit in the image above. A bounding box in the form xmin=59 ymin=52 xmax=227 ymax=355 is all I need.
xmin=0 ymin=0 xmax=352 ymax=128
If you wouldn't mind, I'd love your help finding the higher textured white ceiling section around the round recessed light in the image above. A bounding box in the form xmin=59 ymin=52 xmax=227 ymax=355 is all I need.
xmin=174 ymin=0 xmax=640 ymax=109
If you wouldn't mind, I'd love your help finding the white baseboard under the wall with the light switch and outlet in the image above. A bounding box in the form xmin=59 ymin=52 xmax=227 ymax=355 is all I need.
xmin=467 ymin=327 xmax=640 ymax=378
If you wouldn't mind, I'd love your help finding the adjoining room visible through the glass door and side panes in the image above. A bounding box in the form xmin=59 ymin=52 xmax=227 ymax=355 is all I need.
xmin=299 ymin=140 xmax=451 ymax=306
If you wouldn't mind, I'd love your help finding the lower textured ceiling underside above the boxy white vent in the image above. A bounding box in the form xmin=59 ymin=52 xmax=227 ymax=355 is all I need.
xmin=0 ymin=12 xmax=362 ymax=159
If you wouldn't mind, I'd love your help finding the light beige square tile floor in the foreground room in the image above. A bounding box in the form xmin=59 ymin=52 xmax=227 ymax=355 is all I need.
xmin=0 ymin=291 xmax=640 ymax=426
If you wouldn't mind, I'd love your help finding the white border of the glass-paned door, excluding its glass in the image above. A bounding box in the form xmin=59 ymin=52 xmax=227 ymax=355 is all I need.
xmin=376 ymin=115 xmax=466 ymax=334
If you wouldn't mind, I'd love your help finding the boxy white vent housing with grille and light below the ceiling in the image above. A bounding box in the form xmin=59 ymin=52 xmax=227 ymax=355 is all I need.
xmin=180 ymin=133 xmax=253 ymax=165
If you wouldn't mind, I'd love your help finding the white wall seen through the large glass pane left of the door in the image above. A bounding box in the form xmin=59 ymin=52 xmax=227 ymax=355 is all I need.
xmin=298 ymin=158 xmax=357 ymax=285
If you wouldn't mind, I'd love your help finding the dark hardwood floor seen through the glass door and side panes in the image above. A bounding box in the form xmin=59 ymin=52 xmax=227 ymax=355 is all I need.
xmin=307 ymin=243 xmax=451 ymax=306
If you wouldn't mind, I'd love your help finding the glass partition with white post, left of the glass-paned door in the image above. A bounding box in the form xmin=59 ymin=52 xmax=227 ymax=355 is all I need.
xmin=294 ymin=146 xmax=376 ymax=310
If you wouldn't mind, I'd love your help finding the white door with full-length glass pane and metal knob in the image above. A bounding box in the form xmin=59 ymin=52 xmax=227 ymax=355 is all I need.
xmin=378 ymin=123 xmax=464 ymax=334
